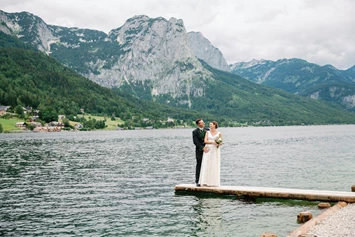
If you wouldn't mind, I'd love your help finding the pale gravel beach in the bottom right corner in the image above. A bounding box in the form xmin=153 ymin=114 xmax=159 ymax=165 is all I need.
xmin=307 ymin=204 xmax=355 ymax=237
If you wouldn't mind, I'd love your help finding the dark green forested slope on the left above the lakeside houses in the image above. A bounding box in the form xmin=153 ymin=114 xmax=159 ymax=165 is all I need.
xmin=0 ymin=45 xmax=214 ymax=123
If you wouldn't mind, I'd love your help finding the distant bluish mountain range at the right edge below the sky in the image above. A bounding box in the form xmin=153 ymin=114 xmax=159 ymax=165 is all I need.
xmin=230 ymin=58 xmax=355 ymax=111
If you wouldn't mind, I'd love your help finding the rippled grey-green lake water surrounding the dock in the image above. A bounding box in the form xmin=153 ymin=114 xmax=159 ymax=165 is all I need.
xmin=0 ymin=125 xmax=355 ymax=237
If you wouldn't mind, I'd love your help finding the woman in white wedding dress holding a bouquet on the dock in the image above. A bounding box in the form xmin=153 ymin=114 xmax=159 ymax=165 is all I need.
xmin=199 ymin=121 xmax=222 ymax=186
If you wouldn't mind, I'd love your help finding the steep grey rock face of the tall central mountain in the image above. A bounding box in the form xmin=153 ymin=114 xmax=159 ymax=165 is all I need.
xmin=94 ymin=16 xmax=211 ymax=101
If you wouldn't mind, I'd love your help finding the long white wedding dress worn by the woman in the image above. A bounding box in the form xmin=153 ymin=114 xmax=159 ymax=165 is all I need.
xmin=199 ymin=131 xmax=221 ymax=186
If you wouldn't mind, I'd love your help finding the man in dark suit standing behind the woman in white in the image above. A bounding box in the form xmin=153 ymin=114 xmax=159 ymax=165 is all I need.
xmin=192 ymin=118 xmax=208 ymax=187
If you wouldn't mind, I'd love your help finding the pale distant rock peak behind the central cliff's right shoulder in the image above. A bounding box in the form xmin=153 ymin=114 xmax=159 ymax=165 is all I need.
xmin=187 ymin=32 xmax=230 ymax=72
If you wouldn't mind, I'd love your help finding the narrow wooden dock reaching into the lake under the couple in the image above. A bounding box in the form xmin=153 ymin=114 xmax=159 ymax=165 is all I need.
xmin=175 ymin=184 xmax=355 ymax=203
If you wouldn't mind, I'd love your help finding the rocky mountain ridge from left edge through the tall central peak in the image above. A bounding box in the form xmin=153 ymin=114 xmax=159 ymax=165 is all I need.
xmin=0 ymin=12 xmax=211 ymax=106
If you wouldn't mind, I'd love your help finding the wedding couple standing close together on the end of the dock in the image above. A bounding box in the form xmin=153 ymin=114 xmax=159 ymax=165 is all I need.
xmin=192 ymin=119 xmax=222 ymax=187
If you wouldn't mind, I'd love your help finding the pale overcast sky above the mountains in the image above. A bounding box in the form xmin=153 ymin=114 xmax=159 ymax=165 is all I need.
xmin=0 ymin=0 xmax=355 ymax=69
